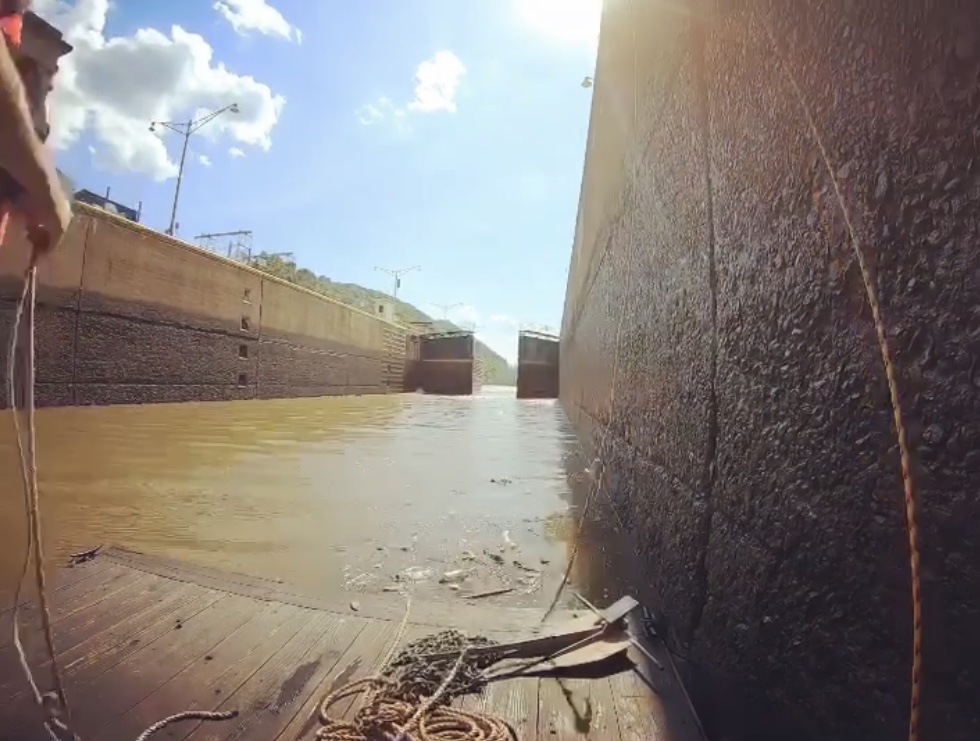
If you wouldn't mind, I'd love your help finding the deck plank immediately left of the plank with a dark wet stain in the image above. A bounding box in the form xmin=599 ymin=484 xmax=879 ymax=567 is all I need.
xmin=99 ymin=602 xmax=316 ymax=741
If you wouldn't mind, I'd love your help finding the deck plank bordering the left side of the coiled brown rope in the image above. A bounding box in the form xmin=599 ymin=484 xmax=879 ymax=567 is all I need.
xmin=263 ymin=620 xmax=398 ymax=741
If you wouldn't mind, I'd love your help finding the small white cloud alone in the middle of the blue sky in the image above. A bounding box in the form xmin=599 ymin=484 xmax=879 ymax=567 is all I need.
xmin=355 ymin=51 xmax=466 ymax=126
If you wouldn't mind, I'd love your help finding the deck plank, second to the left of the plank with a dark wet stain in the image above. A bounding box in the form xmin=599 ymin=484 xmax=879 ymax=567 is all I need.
xmin=65 ymin=595 xmax=256 ymax=738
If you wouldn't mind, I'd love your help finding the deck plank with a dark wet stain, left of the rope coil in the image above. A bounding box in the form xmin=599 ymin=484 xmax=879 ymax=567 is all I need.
xmin=180 ymin=613 xmax=364 ymax=741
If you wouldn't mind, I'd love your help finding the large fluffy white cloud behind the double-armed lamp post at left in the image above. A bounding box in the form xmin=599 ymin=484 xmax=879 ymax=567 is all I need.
xmin=34 ymin=0 xmax=285 ymax=180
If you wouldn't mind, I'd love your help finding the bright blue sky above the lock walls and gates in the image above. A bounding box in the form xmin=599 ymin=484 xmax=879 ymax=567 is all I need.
xmin=36 ymin=0 xmax=598 ymax=359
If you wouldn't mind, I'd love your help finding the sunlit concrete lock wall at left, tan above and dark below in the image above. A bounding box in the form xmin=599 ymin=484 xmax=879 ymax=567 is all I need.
xmin=0 ymin=204 xmax=405 ymax=405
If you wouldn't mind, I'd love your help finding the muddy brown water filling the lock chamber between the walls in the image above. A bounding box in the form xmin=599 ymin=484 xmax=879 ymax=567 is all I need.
xmin=0 ymin=387 xmax=596 ymax=606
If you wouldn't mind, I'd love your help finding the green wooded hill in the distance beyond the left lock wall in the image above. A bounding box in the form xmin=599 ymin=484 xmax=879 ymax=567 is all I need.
xmin=251 ymin=252 xmax=517 ymax=386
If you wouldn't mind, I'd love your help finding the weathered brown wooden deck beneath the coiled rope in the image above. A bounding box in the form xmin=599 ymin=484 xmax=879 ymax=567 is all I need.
xmin=0 ymin=550 xmax=701 ymax=741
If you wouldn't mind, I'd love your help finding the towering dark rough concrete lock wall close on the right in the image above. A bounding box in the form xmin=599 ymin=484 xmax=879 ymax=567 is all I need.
xmin=561 ymin=0 xmax=980 ymax=739
